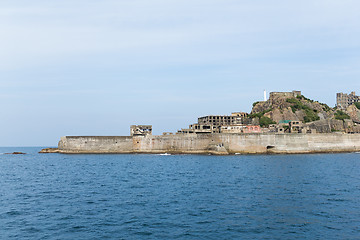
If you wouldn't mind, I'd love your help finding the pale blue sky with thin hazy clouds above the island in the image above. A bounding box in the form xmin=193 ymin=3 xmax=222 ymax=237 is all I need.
xmin=0 ymin=0 xmax=360 ymax=146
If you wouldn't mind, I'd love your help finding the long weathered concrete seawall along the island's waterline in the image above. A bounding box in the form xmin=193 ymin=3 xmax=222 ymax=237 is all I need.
xmin=41 ymin=133 xmax=360 ymax=155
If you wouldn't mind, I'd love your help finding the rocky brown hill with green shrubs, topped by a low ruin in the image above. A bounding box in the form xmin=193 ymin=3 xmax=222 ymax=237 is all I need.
xmin=245 ymin=91 xmax=360 ymax=133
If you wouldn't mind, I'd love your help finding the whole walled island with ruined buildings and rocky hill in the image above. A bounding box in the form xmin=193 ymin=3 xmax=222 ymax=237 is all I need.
xmin=41 ymin=91 xmax=360 ymax=155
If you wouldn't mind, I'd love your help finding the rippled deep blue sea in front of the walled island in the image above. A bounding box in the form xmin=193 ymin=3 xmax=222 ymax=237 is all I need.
xmin=0 ymin=148 xmax=360 ymax=239
